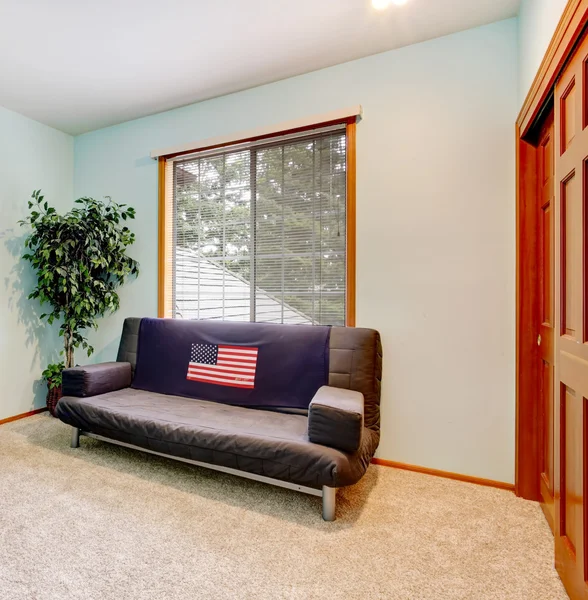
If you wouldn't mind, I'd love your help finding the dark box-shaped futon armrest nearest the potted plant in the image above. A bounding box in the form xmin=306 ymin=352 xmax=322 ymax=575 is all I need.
xmin=62 ymin=362 xmax=131 ymax=398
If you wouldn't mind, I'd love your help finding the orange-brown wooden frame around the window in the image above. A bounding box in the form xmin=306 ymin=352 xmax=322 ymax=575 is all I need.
xmin=157 ymin=116 xmax=357 ymax=327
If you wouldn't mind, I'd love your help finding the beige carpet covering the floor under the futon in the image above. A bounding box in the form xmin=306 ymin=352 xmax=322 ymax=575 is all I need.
xmin=0 ymin=415 xmax=567 ymax=600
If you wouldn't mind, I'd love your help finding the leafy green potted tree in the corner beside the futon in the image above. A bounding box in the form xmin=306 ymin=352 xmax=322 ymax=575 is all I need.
xmin=20 ymin=190 xmax=139 ymax=414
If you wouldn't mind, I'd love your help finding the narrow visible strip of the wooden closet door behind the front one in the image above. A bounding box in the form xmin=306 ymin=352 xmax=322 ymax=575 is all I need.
xmin=536 ymin=110 xmax=555 ymax=531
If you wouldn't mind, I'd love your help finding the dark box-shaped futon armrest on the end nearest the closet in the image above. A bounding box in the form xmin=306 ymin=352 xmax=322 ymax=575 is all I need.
xmin=308 ymin=385 xmax=364 ymax=452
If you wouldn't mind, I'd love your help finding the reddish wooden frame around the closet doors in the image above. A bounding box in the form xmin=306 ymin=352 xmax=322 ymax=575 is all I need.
xmin=515 ymin=0 xmax=588 ymax=500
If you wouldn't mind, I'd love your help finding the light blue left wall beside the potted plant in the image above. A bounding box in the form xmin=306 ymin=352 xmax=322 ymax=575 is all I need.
xmin=0 ymin=107 xmax=73 ymax=420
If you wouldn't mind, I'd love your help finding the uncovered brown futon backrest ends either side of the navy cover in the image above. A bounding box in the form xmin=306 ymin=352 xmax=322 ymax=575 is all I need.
xmin=117 ymin=317 xmax=382 ymax=433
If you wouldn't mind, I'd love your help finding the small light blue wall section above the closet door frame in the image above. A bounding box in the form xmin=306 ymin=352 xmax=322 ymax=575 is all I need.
xmin=519 ymin=0 xmax=568 ymax=106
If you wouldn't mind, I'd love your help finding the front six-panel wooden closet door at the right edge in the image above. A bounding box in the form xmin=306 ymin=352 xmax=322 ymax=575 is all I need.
xmin=554 ymin=34 xmax=588 ymax=599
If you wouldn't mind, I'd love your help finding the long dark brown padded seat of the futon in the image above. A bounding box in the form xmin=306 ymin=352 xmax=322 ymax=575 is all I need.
xmin=57 ymin=388 xmax=378 ymax=488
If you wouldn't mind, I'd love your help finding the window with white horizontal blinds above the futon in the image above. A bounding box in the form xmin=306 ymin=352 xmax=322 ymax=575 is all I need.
xmin=160 ymin=123 xmax=355 ymax=325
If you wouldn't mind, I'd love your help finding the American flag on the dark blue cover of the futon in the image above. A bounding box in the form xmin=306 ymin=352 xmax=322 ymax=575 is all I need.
xmin=186 ymin=343 xmax=258 ymax=389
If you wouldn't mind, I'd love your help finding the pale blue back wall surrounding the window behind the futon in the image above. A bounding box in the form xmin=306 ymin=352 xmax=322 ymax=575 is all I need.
xmin=74 ymin=19 xmax=518 ymax=482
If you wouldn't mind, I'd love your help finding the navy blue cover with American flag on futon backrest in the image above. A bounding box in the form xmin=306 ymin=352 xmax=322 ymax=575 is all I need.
xmin=132 ymin=318 xmax=330 ymax=409
